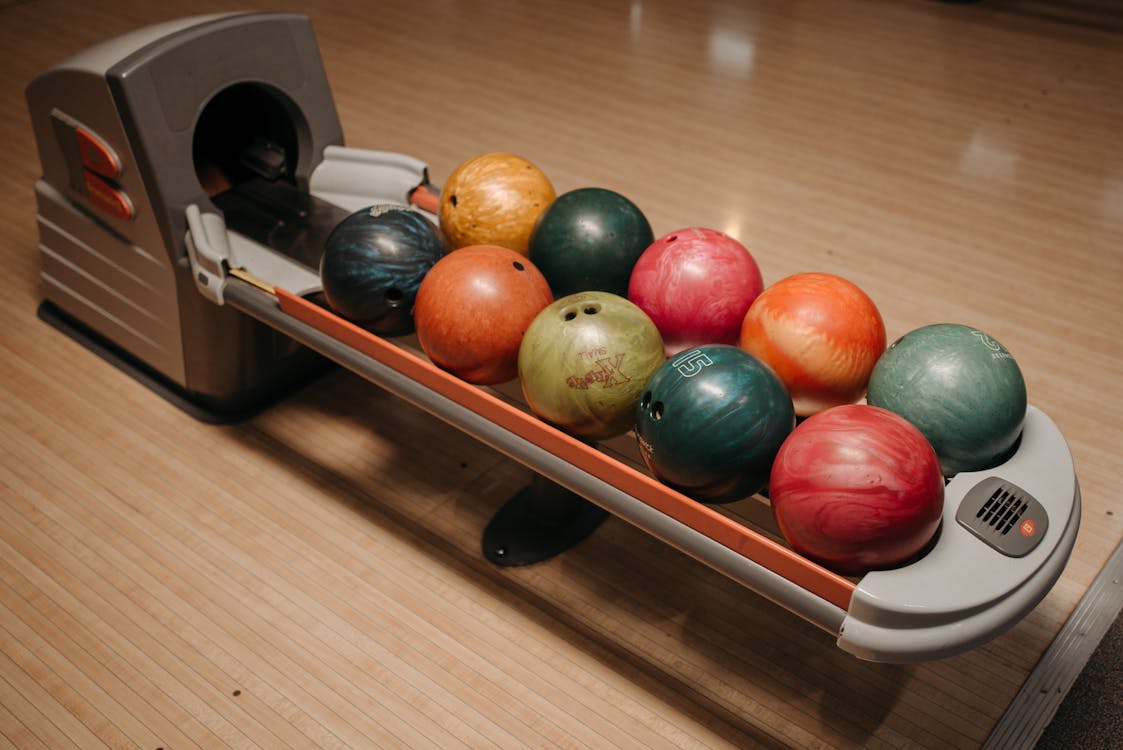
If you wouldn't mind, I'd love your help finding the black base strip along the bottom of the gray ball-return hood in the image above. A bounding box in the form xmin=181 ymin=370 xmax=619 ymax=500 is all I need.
xmin=36 ymin=301 xmax=335 ymax=424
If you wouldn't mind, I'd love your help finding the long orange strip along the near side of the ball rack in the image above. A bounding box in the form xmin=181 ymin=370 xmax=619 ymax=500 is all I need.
xmin=274 ymin=287 xmax=855 ymax=610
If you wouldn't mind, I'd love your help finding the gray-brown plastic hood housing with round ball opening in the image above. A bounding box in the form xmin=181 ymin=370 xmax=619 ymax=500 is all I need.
xmin=27 ymin=13 xmax=348 ymax=411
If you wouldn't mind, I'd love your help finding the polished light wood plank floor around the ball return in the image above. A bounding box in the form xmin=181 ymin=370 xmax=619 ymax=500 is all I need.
xmin=0 ymin=0 xmax=1123 ymax=749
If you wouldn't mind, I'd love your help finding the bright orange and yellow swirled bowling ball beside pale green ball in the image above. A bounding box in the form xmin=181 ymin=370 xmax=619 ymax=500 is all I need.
xmin=739 ymin=273 xmax=885 ymax=417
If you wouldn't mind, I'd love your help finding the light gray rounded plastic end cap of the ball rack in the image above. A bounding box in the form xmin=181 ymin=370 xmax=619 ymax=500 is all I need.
xmin=838 ymin=405 xmax=1080 ymax=662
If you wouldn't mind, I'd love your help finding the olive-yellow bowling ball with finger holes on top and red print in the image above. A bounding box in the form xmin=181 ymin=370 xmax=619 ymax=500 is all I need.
xmin=519 ymin=292 xmax=664 ymax=440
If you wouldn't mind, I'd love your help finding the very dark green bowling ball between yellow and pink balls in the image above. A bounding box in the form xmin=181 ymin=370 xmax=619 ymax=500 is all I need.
xmin=530 ymin=188 xmax=655 ymax=296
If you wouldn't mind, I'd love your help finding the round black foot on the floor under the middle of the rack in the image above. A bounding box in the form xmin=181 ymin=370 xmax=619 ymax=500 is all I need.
xmin=483 ymin=475 xmax=609 ymax=567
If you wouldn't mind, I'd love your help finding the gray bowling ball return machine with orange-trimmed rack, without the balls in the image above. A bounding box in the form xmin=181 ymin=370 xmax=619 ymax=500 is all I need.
xmin=27 ymin=13 xmax=1080 ymax=662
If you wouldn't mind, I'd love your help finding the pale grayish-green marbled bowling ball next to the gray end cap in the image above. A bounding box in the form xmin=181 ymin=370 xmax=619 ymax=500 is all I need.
xmin=867 ymin=323 xmax=1026 ymax=476
